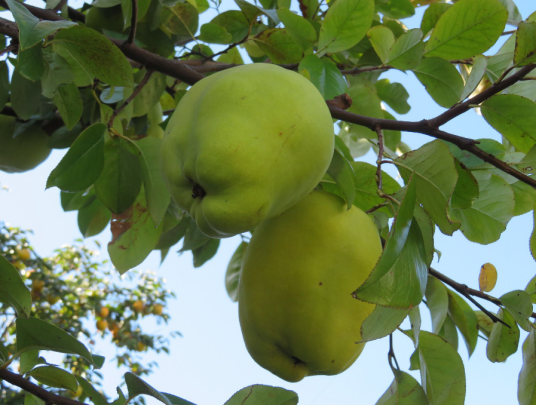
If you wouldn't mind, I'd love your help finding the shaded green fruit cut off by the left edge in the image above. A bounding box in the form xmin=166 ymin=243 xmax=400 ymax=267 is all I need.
xmin=0 ymin=115 xmax=51 ymax=173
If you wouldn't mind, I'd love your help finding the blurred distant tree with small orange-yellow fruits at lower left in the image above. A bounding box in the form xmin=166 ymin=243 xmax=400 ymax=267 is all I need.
xmin=0 ymin=226 xmax=177 ymax=404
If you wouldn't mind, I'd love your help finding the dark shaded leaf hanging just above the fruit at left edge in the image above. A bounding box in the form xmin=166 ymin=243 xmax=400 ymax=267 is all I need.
xmin=10 ymin=69 xmax=42 ymax=120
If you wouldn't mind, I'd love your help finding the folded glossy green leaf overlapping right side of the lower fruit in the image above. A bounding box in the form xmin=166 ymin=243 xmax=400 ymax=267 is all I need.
xmin=354 ymin=178 xmax=428 ymax=309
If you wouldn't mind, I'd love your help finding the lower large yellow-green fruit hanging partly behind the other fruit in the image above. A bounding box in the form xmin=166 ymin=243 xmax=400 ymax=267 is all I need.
xmin=238 ymin=191 xmax=382 ymax=382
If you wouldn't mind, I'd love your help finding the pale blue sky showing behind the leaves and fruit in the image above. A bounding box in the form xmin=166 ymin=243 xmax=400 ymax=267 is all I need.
xmin=0 ymin=0 xmax=536 ymax=405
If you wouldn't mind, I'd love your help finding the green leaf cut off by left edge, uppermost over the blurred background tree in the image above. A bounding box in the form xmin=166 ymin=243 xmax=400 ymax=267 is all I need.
xmin=0 ymin=255 xmax=32 ymax=317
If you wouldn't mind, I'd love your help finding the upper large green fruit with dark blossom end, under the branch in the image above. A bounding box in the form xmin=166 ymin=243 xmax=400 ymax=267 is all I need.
xmin=162 ymin=63 xmax=334 ymax=238
